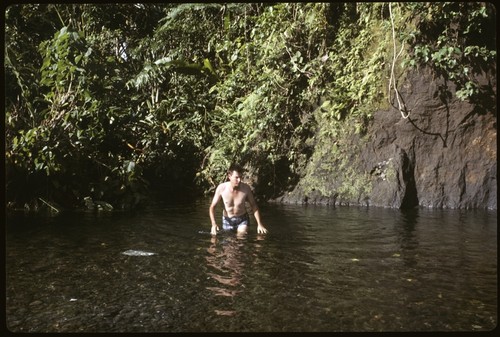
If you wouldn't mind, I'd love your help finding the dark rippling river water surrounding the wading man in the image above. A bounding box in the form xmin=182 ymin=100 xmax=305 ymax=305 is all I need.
xmin=6 ymin=200 xmax=498 ymax=332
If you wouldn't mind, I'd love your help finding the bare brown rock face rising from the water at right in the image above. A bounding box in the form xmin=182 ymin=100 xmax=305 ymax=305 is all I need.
xmin=278 ymin=67 xmax=497 ymax=209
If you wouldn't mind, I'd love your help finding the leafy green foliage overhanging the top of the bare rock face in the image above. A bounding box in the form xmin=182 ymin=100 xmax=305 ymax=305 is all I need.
xmin=402 ymin=2 xmax=497 ymax=101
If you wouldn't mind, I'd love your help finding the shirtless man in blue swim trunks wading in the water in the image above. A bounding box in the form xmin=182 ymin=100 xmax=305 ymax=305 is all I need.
xmin=209 ymin=164 xmax=267 ymax=235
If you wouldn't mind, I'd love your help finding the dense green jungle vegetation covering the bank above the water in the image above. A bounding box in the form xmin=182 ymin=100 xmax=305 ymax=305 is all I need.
xmin=5 ymin=2 xmax=496 ymax=209
